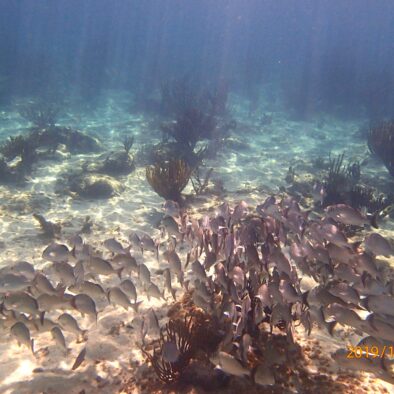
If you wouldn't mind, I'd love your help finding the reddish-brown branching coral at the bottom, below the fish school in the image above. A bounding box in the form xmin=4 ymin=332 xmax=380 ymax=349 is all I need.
xmin=142 ymin=316 xmax=197 ymax=384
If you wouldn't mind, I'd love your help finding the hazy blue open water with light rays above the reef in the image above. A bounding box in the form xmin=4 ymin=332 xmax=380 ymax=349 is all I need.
xmin=0 ymin=0 xmax=394 ymax=119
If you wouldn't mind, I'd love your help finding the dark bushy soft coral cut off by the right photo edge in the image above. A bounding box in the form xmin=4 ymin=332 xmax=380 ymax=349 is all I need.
xmin=368 ymin=121 xmax=394 ymax=176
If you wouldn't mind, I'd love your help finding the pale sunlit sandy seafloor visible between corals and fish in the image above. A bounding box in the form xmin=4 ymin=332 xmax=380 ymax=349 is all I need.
xmin=0 ymin=91 xmax=394 ymax=394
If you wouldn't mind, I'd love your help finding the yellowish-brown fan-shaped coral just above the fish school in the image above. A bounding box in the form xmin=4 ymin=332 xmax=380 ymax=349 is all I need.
xmin=146 ymin=159 xmax=192 ymax=202
